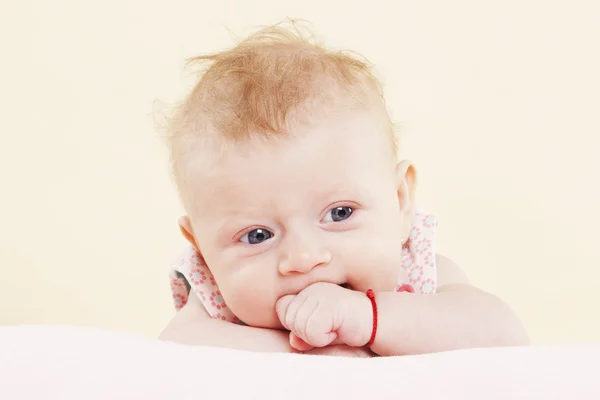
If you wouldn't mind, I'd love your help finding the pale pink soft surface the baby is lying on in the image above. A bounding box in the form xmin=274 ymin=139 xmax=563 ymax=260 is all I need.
xmin=0 ymin=326 xmax=600 ymax=400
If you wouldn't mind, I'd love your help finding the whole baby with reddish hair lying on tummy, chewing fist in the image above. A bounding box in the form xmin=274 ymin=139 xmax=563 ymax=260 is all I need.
xmin=161 ymin=22 xmax=527 ymax=356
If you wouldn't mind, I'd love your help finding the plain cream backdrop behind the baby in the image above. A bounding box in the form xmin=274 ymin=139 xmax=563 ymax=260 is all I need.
xmin=0 ymin=0 xmax=600 ymax=343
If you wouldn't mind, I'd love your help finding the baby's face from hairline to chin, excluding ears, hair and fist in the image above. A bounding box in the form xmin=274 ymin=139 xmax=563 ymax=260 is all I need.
xmin=190 ymin=111 xmax=410 ymax=328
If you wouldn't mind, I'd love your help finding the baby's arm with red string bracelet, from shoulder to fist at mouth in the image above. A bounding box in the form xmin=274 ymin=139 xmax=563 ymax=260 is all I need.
xmin=276 ymin=256 xmax=528 ymax=356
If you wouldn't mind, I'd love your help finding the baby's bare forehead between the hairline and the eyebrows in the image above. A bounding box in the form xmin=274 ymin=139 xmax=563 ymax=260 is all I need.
xmin=188 ymin=125 xmax=395 ymax=216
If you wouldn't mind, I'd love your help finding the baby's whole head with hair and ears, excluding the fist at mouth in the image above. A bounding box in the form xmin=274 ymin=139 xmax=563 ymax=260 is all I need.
xmin=170 ymin=22 xmax=415 ymax=328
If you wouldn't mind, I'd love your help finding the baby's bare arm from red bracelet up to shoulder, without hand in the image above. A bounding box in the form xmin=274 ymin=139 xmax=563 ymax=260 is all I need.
xmin=371 ymin=256 xmax=529 ymax=355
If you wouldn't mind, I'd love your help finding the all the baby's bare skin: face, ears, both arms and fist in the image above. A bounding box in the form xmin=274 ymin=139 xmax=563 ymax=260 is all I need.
xmin=161 ymin=109 xmax=527 ymax=357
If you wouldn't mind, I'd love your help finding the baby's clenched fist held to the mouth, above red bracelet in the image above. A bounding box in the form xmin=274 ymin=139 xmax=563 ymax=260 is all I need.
xmin=275 ymin=282 xmax=373 ymax=351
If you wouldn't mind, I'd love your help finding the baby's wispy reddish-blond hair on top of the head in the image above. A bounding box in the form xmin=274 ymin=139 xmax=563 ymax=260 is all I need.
xmin=168 ymin=21 xmax=395 ymax=191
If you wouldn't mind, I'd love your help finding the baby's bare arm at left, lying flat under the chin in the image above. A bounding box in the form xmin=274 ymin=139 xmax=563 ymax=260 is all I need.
xmin=159 ymin=293 xmax=294 ymax=353
